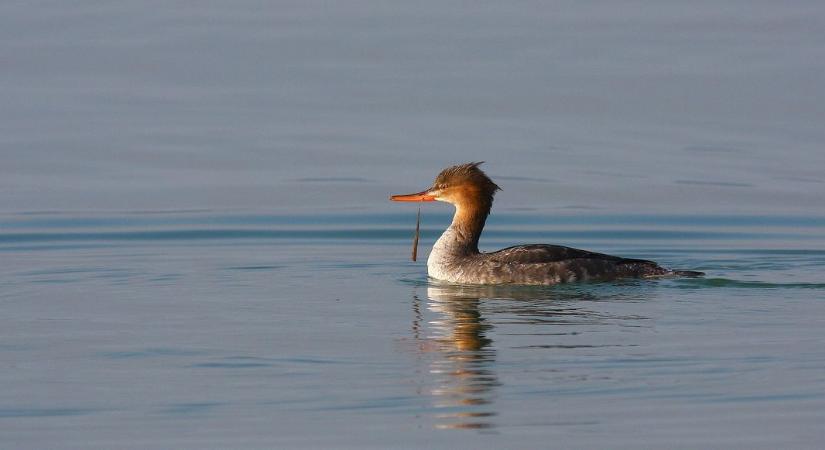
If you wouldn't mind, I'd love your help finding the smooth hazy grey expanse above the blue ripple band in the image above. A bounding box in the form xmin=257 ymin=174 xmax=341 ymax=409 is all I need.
xmin=0 ymin=0 xmax=825 ymax=214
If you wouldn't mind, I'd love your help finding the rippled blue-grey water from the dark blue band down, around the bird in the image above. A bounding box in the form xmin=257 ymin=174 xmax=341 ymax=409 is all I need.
xmin=0 ymin=212 xmax=825 ymax=448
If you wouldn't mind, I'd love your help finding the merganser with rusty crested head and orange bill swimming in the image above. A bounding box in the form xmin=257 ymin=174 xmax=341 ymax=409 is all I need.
xmin=390 ymin=162 xmax=703 ymax=285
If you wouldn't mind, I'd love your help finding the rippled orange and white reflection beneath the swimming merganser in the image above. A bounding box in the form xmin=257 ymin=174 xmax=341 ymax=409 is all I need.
xmin=412 ymin=284 xmax=652 ymax=429
